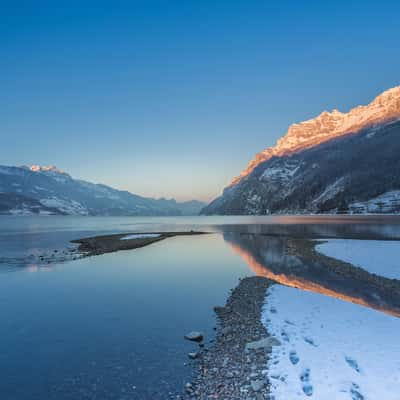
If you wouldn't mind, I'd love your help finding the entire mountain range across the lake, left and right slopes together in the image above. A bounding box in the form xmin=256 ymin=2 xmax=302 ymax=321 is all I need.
xmin=0 ymin=86 xmax=400 ymax=216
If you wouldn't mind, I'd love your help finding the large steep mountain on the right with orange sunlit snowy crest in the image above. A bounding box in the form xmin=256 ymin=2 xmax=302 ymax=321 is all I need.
xmin=202 ymin=86 xmax=400 ymax=214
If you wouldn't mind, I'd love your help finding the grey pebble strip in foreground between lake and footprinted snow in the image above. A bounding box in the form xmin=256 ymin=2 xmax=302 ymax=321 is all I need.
xmin=184 ymin=276 xmax=280 ymax=400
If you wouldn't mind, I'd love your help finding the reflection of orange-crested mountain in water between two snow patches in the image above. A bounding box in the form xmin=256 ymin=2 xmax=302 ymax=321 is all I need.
xmin=223 ymin=232 xmax=400 ymax=317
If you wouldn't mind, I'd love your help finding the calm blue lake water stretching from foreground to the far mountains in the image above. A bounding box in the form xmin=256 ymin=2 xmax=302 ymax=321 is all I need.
xmin=0 ymin=216 xmax=400 ymax=400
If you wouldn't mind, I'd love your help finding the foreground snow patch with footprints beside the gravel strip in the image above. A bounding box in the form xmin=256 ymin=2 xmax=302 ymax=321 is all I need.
xmin=263 ymin=285 xmax=400 ymax=400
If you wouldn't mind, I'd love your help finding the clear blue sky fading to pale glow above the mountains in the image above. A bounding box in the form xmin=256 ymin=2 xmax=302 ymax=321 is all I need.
xmin=0 ymin=0 xmax=400 ymax=199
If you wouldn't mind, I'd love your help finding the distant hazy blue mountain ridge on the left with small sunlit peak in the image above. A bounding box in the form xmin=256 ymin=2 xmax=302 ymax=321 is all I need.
xmin=0 ymin=165 xmax=204 ymax=215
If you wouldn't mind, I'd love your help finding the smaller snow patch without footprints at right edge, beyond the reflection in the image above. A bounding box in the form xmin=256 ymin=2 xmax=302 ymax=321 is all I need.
xmin=316 ymin=239 xmax=400 ymax=280
